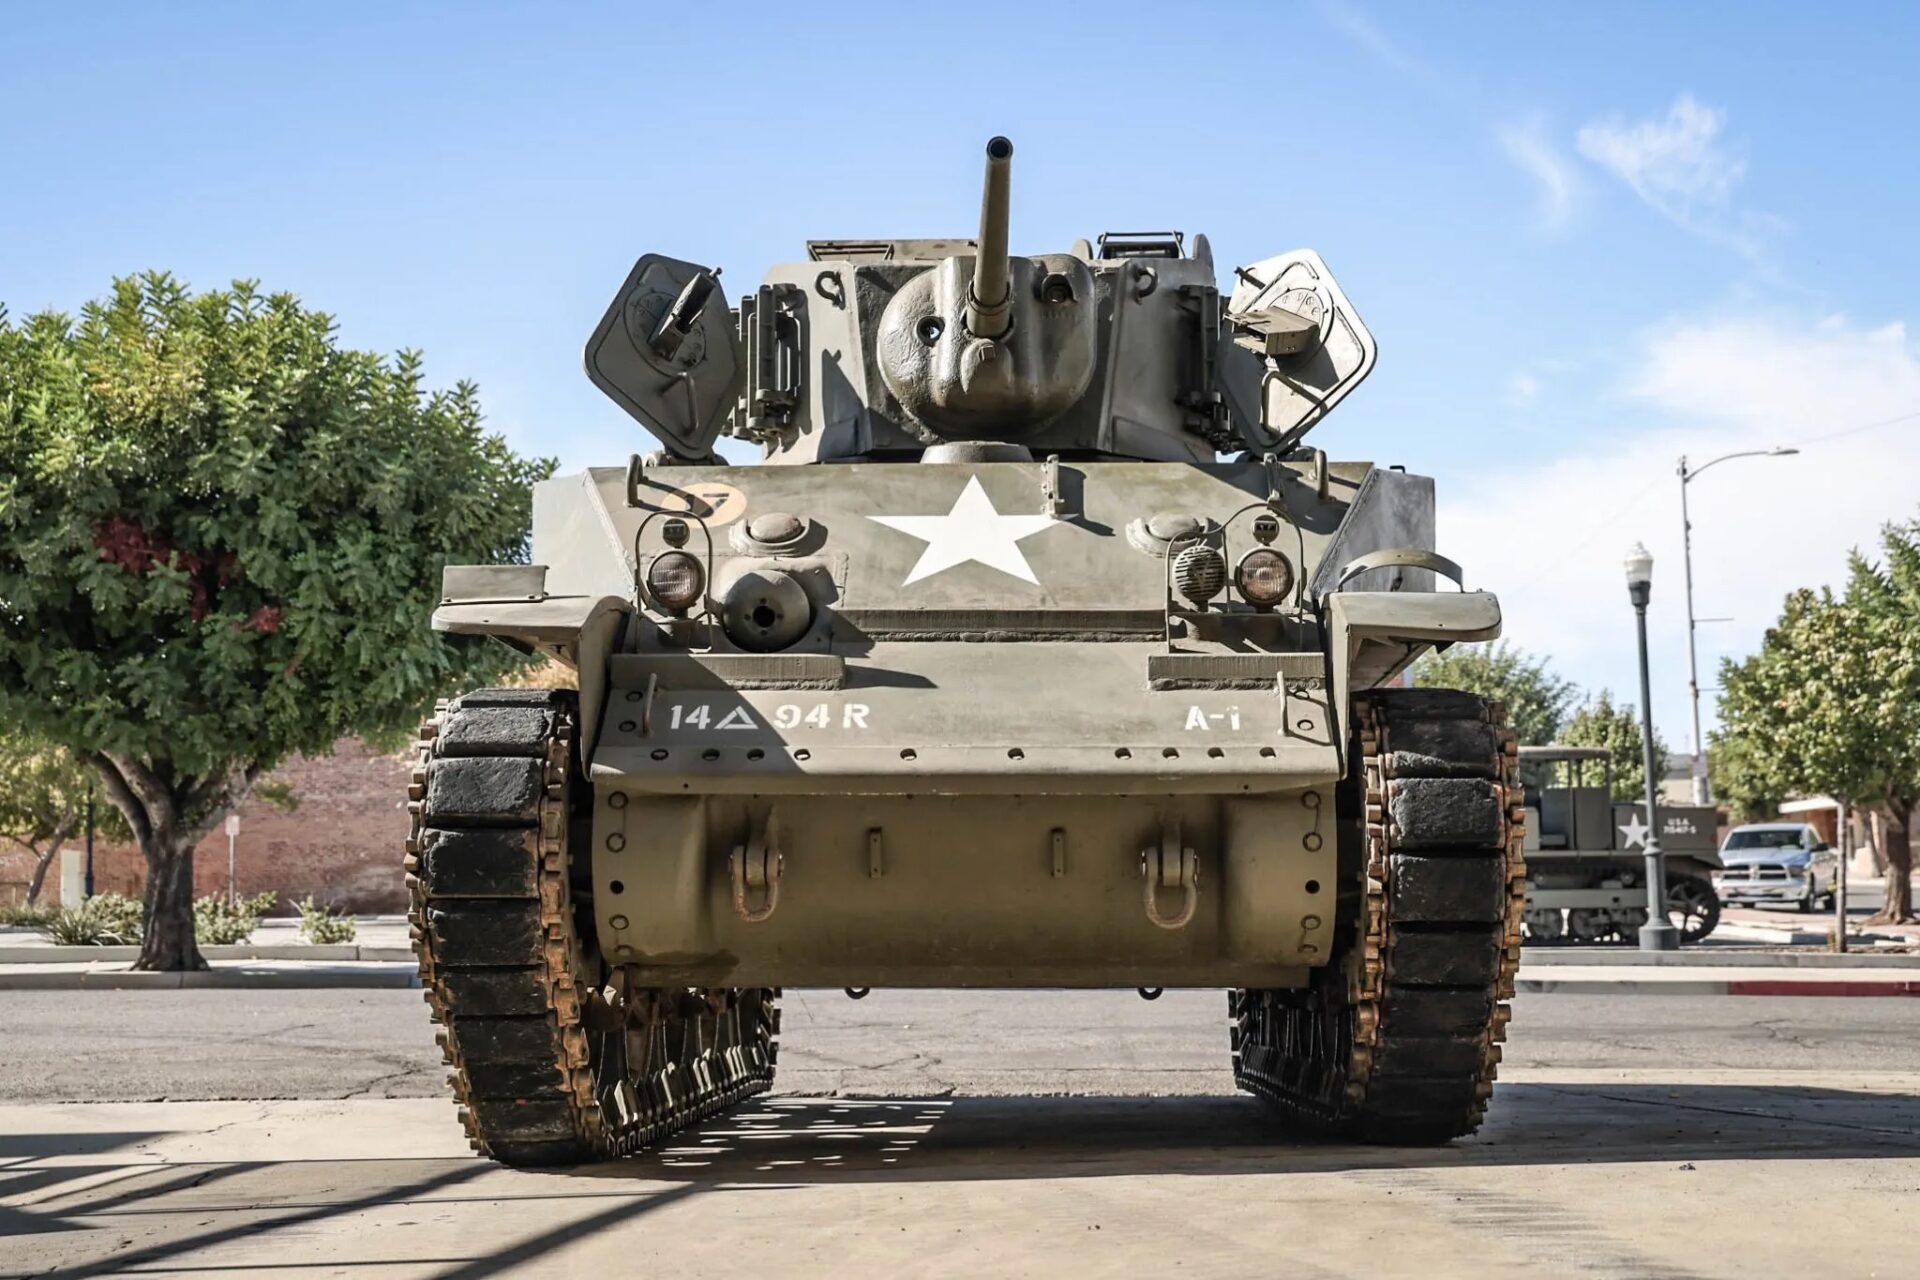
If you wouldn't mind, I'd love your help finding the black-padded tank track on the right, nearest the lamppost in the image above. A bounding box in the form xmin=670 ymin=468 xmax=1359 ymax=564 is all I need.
xmin=1229 ymin=689 xmax=1526 ymax=1146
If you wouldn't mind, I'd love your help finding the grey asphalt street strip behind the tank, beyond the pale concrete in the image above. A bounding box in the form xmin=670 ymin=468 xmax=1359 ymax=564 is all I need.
xmin=0 ymin=990 xmax=1920 ymax=1102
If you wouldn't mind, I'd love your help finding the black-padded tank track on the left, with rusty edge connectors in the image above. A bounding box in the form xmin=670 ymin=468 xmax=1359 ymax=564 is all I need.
xmin=407 ymin=689 xmax=780 ymax=1165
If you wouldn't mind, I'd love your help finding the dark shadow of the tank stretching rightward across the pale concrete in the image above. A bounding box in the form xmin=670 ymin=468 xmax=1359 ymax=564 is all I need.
xmin=568 ymin=1084 xmax=1920 ymax=1184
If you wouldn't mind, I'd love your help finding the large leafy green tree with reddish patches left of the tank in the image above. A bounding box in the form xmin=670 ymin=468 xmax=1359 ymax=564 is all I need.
xmin=0 ymin=274 xmax=553 ymax=969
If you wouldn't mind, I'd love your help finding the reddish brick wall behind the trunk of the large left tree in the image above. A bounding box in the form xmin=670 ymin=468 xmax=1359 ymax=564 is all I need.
xmin=0 ymin=739 xmax=411 ymax=912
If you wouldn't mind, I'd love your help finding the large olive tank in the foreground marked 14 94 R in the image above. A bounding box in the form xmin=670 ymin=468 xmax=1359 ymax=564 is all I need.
xmin=407 ymin=138 xmax=1524 ymax=1165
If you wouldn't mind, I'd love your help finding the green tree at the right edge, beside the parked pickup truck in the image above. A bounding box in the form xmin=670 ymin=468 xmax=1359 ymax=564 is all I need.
xmin=1720 ymin=524 xmax=1920 ymax=923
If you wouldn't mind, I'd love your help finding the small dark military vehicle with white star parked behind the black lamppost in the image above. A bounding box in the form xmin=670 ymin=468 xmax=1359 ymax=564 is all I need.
xmin=1521 ymin=745 xmax=1722 ymax=944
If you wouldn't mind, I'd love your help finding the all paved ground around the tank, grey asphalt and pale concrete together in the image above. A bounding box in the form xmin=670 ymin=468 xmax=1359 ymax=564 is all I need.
xmin=0 ymin=992 xmax=1920 ymax=1280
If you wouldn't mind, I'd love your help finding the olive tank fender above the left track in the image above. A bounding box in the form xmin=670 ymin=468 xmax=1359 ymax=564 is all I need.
xmin=434 ymin=564 xmax=634 ymax=764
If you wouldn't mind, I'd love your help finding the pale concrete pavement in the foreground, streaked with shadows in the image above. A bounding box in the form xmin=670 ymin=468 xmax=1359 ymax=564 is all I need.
xmin=0 ymin=1073 xmax=1920 ymax=1280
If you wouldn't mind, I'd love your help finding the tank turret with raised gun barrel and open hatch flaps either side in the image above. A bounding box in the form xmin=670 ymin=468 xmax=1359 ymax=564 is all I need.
xmin=586 ymin=136 xmax=1373 ymax=464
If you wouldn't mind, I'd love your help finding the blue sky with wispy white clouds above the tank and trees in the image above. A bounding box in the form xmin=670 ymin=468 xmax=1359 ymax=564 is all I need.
xmin=0 ymin=0 xmax=1920 ymax=747
